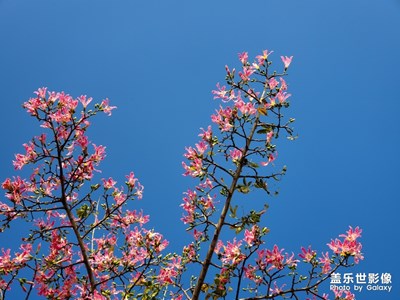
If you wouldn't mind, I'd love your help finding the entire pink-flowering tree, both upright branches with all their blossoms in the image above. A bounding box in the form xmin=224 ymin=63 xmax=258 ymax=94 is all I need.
xmin=0 ymin=50 xmax=363 ymax=300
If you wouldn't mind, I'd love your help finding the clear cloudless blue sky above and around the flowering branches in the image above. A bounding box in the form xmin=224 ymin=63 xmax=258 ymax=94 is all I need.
xmin=0 ymin=0 xmax=400 ymax=300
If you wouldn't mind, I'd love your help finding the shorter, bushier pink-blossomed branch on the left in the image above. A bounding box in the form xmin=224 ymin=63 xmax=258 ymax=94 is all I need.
xmin=0 ymin=88 xmax=168 ymax=299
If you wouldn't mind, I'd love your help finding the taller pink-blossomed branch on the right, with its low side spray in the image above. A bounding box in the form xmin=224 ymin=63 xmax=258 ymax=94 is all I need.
xmin=181 ymin=50 xmax=362 ymax=299
